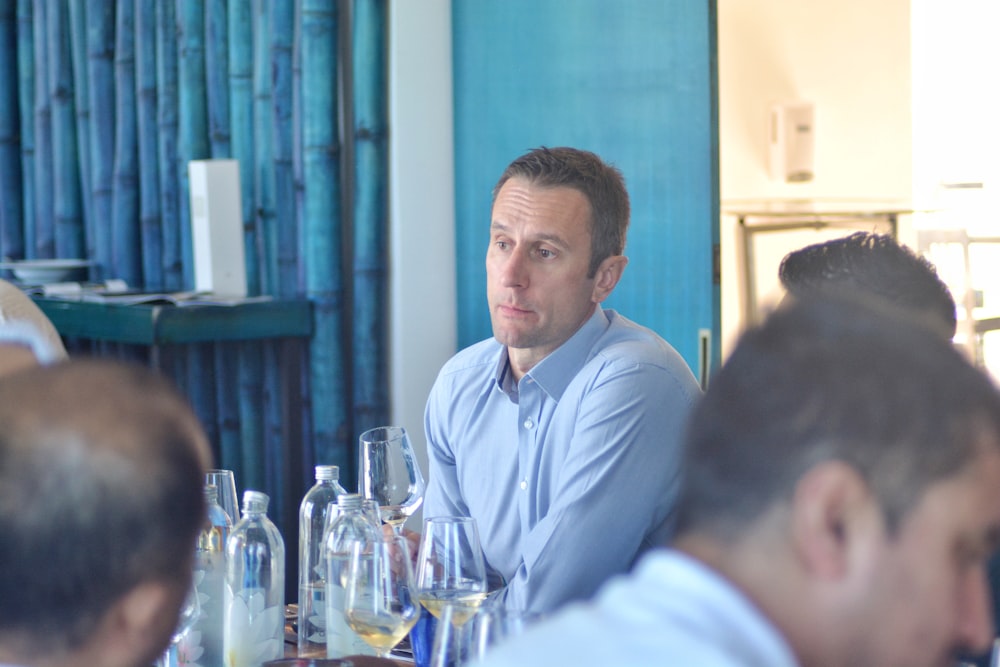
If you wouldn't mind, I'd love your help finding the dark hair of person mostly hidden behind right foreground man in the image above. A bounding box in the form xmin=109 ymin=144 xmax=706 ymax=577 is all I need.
xmin=778 ymin=232 xmax=956 ymax=338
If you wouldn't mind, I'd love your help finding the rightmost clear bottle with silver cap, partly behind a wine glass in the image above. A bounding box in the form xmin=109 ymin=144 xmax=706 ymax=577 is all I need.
xmin=326 ymin=493 xmax=381 ymax=658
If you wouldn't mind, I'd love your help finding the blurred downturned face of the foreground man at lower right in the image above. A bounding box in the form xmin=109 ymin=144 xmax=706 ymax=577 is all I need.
xmin=852 ymin=451 xmax=1000 ymax=667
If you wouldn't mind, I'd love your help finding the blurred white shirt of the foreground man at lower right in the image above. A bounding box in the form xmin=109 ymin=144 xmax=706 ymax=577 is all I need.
xmin=470 ymin=549 xmax=798 ymax=667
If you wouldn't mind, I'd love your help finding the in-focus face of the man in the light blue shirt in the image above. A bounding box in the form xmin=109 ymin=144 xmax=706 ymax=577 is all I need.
xmin=486 ymin=178 xmax=612 ymax=377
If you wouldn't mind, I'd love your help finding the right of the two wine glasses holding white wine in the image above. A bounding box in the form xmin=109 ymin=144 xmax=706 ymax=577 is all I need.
xmin=417 ymin=516 xmax=486 ymax=625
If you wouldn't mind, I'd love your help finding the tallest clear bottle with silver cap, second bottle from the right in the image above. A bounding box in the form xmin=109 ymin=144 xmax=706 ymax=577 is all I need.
xmin=298 ymin=466 xmax=347 ymax=655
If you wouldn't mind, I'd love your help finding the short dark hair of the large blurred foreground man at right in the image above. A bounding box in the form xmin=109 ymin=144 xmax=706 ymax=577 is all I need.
xmin=678 ymin=292 xmax=1000 ymax=539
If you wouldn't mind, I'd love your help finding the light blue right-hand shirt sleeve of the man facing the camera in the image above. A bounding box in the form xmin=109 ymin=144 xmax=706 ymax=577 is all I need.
xmin=502 ymin=363 xmax=698 ymax=612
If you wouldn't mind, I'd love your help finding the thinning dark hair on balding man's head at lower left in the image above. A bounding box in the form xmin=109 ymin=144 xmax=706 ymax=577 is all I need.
xmin=0 ymin=361 xmax=210 ymax=652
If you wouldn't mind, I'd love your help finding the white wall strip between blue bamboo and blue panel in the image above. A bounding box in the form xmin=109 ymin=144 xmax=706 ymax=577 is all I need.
xmin=389 ymin=0 xmax=457 ymax=529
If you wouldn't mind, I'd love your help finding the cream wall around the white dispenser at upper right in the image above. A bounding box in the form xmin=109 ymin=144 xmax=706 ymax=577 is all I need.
xmin=718 ymin=0 xmax=912 ymax=355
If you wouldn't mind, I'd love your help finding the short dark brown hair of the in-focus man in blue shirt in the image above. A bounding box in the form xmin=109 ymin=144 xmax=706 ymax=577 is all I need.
xmin=493 ymin=146 xmax=629 ymax=278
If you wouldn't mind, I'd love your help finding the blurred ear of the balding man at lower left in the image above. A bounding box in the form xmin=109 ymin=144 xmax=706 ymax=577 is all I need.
xmin=99 ymin=581 xmax=181 ymax=665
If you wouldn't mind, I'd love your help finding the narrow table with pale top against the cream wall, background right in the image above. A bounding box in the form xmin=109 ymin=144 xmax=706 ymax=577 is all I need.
xmin=722 ymin=199 xmax=915 ymax=324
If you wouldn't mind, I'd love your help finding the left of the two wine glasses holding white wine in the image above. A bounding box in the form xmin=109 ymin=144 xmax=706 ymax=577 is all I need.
xmin=344 ymin=534 xmax=420 ymax=658
